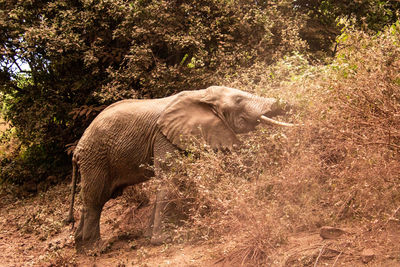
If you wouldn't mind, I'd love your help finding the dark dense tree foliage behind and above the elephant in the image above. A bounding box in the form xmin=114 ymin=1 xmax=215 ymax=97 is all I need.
xmin=0 ymin=0 xmax=398 ymax=186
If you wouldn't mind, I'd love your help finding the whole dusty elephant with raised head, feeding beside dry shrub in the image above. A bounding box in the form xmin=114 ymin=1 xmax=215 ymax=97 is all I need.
xmin=67 ymin=86 xmax=293 ymax=251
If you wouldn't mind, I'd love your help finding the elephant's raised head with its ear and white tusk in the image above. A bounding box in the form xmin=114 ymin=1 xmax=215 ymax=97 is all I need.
xmin=157 ymin=86 xmax=292 ymax=151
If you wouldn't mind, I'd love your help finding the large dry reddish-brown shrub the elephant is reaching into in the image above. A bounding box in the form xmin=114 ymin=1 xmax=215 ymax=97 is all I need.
xmin=147 ymin=22 xmax=400 ymax=265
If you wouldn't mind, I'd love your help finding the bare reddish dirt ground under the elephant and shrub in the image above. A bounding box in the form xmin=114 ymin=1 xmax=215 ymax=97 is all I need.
xmin=0 ymin=184 xmax=400 ymax=267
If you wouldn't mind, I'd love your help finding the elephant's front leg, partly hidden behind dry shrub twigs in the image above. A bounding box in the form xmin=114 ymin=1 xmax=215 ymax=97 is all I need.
xmin=148 ymin=134 xmax=177 ymax=245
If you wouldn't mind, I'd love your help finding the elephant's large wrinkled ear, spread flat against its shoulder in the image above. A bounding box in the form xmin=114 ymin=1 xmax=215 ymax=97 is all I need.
xmin=157 ymin=90 xmax=238 ymax=149
